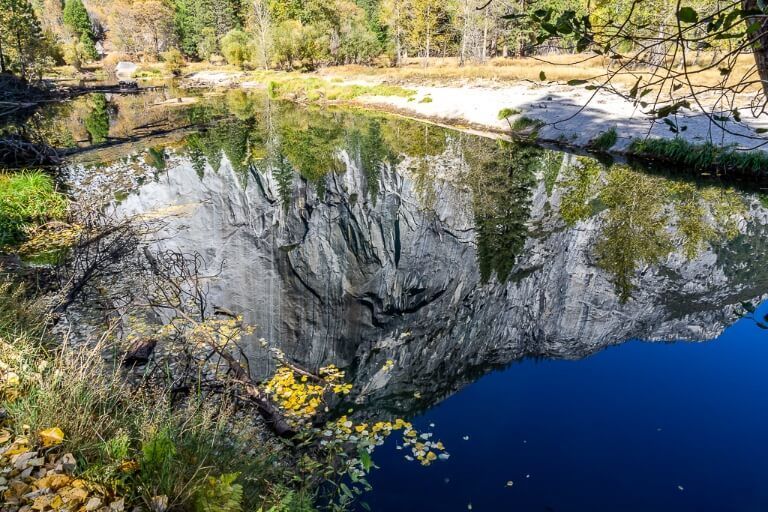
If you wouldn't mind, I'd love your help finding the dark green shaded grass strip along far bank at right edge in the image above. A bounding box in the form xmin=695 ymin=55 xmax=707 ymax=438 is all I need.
xmin=629 ymin=138 xmax=768 ymax=178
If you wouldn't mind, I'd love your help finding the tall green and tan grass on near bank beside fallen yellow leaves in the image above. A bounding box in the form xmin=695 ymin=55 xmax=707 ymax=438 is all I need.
xmin=0 ymin=281 xmax=312 ymax=512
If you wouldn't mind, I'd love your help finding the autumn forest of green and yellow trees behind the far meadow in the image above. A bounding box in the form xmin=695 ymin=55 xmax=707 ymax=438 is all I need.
xmin=0 ymin=0 xmax=748 ymax=78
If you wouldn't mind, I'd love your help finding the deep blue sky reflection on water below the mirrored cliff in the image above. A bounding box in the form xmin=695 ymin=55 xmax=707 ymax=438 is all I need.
xmin=366 ymin=305 xmax=768 ymax=512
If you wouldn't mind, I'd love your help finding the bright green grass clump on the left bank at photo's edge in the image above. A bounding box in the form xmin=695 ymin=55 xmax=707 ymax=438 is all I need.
xmin=0 ymin=171 xmax=68 ymax=247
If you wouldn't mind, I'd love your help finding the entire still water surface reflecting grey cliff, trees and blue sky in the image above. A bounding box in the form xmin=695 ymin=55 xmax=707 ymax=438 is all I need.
xmin=46 ymin=91 xmax=768 ymax=512
